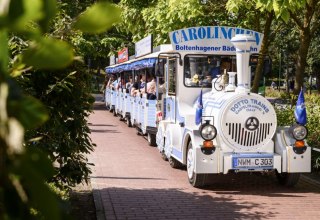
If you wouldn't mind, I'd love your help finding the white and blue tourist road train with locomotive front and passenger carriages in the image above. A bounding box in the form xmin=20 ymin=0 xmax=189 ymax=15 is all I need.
xmin=105 ymin=26 xmax=311 ymax=187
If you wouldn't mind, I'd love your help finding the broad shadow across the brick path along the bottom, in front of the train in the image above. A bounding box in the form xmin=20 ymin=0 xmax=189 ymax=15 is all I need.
xmin=100 ymin=188 xmax=277 ymax=219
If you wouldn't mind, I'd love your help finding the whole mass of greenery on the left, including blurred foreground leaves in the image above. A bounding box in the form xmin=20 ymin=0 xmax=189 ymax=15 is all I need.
xmin=0 ymin=0 xmax=117 ymax=219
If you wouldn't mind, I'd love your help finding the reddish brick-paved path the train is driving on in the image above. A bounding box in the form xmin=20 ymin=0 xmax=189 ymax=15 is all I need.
xmin=89 ymin=100 xmax=320 ymax=220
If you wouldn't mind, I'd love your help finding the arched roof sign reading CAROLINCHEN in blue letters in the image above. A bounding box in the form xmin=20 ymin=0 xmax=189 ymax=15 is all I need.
xmin=169 ymin=26 xmax=263 ymax=54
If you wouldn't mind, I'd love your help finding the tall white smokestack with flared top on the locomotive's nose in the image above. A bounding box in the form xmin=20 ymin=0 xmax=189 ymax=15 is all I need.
xmin=231 ymin=34 xmax=255 ymax=92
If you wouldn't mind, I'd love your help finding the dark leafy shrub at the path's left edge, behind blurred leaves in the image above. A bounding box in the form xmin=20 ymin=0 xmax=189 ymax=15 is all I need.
xmin=20 ymin=63 xmax=94 ymax=187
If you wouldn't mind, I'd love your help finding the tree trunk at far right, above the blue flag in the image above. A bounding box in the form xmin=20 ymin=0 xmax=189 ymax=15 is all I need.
xmin=294 ymin=28 xmax=311 ymax=94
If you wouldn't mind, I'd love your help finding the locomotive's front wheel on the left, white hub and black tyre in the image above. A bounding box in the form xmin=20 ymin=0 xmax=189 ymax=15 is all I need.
xmin=187 ymin=141 xmax=207 ymax=188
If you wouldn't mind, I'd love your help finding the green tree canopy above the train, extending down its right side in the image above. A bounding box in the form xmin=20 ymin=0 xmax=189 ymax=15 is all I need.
xmin=112 ymin=0 xmax=320 ymax=95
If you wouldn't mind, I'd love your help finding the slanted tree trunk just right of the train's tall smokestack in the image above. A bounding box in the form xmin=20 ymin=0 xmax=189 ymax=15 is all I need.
xmin=251 ymin=12 xmax=273 ymax=93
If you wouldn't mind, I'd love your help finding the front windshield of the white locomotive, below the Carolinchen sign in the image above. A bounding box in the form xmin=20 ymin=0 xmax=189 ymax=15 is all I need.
xmin=184 ymin=54 xmax=237 ymax=88
